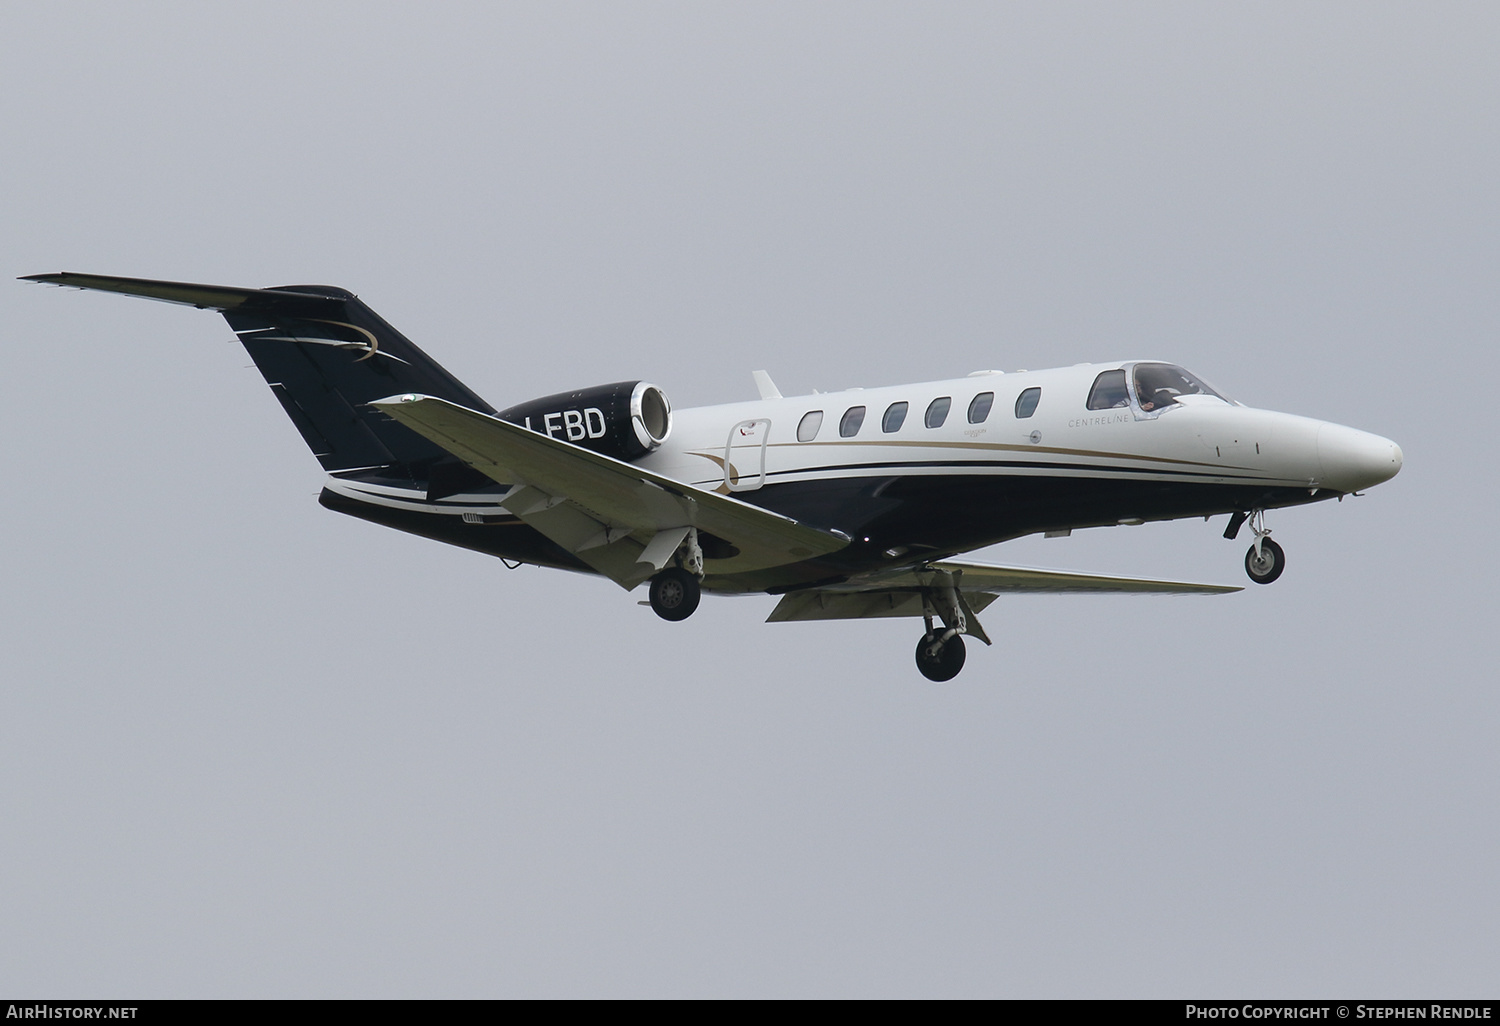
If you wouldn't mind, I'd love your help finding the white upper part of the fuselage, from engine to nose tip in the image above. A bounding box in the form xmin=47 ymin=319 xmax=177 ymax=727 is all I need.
xmin=641 ymin=362 xmax=1401 ymax=498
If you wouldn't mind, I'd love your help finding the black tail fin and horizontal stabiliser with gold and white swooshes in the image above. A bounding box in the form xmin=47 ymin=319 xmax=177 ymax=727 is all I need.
xmin=29 ymin=273 xmax=495 ymax=477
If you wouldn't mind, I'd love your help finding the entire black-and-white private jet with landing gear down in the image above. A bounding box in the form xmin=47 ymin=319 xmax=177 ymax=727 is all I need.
xmin=27 ymin=273 xmax=1401 ymax=681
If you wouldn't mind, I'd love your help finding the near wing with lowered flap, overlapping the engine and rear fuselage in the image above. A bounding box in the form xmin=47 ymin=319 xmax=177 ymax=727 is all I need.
xmin=371 ymin=395 xmax=849 ymax=588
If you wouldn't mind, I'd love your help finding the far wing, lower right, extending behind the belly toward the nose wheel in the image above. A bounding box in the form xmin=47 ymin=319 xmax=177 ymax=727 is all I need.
xmin=767 ymin=560 xmax=1244 ymax=623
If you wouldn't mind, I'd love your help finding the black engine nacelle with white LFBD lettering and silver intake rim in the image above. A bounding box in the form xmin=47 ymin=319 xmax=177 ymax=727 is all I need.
xmin=500 ymin=381 xmax=672 ymax=461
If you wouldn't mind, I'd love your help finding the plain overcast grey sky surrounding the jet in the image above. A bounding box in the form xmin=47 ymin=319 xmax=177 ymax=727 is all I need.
xmin=0 ymin=3 xmax=1500 ymax=998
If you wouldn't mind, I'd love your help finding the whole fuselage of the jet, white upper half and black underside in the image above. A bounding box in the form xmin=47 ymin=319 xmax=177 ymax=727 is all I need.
xmin=326 ymin=362 xmax=1401 ymax=593
